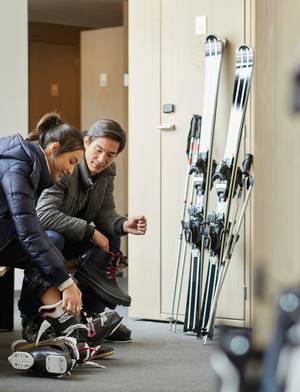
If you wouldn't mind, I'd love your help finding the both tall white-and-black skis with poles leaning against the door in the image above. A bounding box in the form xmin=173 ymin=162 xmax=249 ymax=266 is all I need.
xmin=171 ymin=34 xmax=253 ymax=340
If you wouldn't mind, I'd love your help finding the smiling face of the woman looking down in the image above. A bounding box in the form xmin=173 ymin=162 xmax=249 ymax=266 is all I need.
xmin=45 ymin=143 xmax=84 ymax=181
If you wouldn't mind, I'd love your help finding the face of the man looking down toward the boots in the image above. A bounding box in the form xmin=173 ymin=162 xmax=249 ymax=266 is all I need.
xmin=84 ymin=136 xmax=120 ymax=176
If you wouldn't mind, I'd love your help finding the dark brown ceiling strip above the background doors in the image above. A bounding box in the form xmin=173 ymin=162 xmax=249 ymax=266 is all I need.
xmin=28 ymin=0 xmax=123 ymax=28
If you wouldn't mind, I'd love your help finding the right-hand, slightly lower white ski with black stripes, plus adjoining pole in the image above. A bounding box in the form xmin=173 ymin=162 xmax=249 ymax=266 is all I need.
xmin=197 ymin=45 xmax=254 ymax=341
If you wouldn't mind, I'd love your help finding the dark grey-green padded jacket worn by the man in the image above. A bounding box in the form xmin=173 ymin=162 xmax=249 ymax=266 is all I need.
xmin=37 ymin=159 xmax=126 ymax=240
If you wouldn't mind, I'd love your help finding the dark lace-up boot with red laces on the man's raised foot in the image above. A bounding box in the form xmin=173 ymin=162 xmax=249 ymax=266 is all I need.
xmin=75 ymin=246 xmax=131 ymax=306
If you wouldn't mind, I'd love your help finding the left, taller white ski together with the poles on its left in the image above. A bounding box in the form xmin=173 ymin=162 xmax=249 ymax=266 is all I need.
xmin=170 ymin=34 xmax=224 ymax=331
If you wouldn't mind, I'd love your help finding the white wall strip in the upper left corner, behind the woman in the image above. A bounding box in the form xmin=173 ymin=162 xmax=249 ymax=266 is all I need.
xmin=0 ymin=0 xmax=28 ymax=290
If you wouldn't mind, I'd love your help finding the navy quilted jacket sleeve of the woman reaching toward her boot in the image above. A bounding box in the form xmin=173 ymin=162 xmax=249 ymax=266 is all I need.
xmin=1 ymin=163 xmax=70 ymax=287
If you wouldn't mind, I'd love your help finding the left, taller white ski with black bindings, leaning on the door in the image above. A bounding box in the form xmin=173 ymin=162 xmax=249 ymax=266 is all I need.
xmin=169 ymin=34 xmax=225 ymax=332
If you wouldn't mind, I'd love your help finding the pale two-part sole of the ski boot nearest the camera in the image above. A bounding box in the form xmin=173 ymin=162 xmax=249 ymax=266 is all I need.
xmin=8 ymin=351 xmax=68 ymax=375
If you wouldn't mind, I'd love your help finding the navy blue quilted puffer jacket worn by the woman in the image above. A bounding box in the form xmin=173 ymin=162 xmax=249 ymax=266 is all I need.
xmin=0 ymin=135 xmax=70 ymax=287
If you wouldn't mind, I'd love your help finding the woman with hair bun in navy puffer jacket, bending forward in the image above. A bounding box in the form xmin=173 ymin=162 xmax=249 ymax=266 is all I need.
xmin=0 ymin=113 xmax=84 ymax=315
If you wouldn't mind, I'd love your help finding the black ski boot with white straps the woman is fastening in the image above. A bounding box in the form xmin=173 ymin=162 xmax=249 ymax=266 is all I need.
xmin=37 ymin=301 xmax=123 ymax=344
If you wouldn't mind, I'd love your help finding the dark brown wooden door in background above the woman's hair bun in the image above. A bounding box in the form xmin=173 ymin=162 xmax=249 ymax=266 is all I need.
xmin=29 ymin=27 xmax=80 ymax=129
